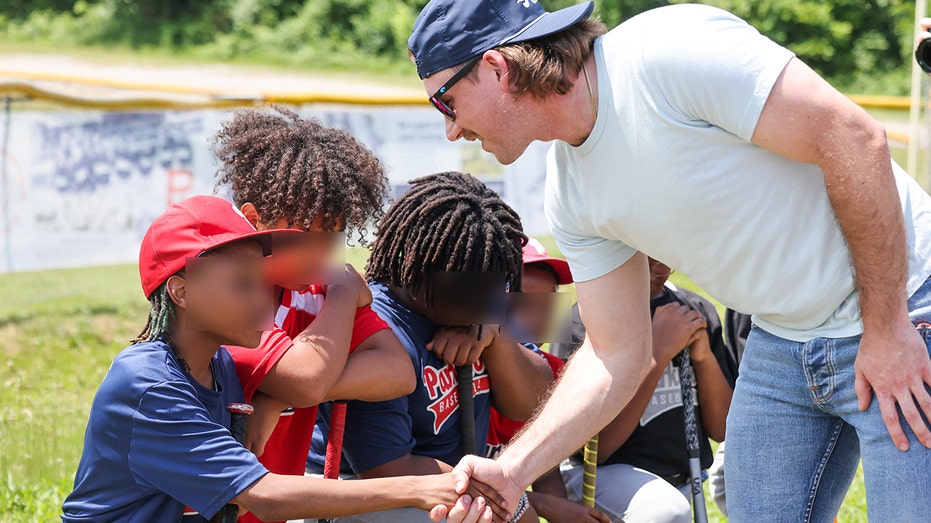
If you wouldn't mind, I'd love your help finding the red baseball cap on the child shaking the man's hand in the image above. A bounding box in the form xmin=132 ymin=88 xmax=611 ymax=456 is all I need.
xmin=139 ymin=196 xmax=288 ymax=298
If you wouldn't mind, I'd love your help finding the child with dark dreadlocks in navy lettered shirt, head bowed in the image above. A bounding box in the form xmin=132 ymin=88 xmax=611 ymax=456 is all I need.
xmin=308 ymin=172 xmax=552 ymax=522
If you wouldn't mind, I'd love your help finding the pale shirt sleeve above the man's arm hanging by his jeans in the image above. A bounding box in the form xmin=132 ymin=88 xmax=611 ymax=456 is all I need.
xmin=643 ymin=5 xmax=794 ymax=141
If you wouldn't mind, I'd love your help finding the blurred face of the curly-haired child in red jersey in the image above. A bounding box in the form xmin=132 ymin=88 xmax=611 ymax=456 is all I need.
xmin=255 ymin=212 xmax=346 ymax=291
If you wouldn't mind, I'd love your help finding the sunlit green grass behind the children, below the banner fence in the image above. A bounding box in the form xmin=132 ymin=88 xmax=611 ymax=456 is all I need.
xmin=0 ymin=247 xmax=866 ymax=523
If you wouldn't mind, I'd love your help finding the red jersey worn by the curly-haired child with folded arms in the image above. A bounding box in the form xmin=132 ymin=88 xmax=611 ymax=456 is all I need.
xmin=227 ymin=285 xmax=389 ymax=523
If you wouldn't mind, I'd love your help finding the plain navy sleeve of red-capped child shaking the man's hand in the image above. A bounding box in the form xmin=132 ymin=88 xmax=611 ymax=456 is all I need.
xmin=128 ymin=383 xmax=268 ymax=519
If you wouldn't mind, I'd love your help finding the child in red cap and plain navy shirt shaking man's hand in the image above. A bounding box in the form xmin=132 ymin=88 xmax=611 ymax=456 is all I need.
xmin=62 ymin=196 xmax=459 ymax=523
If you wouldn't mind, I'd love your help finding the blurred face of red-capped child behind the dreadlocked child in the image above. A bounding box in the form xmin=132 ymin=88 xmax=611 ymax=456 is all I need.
xmin=508 ymin=264 xmax=559 ymax=343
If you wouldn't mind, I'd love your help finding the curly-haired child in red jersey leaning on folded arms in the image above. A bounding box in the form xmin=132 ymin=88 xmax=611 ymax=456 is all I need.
xmin=215 ymin=107 xmax=422 ymax=523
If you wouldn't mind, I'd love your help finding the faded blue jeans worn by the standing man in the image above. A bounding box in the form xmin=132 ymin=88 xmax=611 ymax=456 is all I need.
xmin=724 ymin=280 xmax=931 ymax=523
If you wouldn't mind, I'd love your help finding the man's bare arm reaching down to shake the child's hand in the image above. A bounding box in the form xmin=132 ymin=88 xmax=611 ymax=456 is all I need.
xmin=454 ymin=253 xmax=651 ymax=510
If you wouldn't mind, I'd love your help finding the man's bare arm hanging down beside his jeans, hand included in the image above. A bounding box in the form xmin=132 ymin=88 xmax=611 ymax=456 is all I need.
xmin=752 ymin=59 xmax=931 ymax=450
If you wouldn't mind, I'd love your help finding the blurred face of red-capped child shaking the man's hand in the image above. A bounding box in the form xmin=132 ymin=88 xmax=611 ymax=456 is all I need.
xmin=175 ymin=240 xmax=274 ymax=348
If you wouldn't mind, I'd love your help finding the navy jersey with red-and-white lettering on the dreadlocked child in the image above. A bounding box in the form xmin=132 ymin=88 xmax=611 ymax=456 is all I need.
xmin=308 ymin=282 xmax=491 ymax=473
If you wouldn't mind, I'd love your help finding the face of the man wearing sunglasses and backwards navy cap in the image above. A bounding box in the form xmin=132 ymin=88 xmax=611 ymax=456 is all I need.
xmin=423 ymin=51 xmax=537 ymax=165
